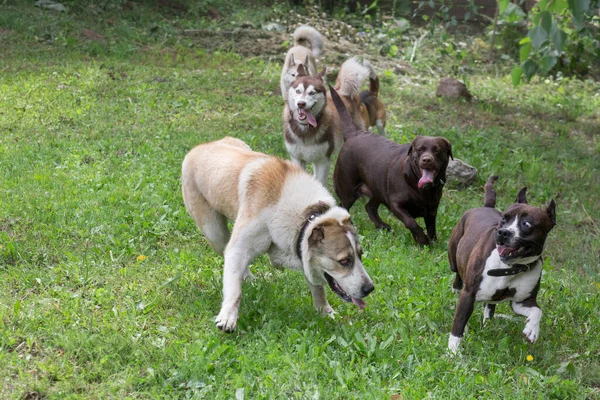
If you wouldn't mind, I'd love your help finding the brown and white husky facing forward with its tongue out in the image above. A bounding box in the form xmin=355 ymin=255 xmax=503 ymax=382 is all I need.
xmin=283 ymin=57 xmax=369 ymax=186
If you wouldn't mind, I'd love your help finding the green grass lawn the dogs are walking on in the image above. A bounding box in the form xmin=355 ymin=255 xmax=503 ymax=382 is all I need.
xmin=0 ymin=2 xmax=600 ymax=399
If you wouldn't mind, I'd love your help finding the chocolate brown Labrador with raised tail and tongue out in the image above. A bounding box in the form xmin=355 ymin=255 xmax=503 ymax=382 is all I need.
xmin=330 ymin=86 xmax=452 ymax=244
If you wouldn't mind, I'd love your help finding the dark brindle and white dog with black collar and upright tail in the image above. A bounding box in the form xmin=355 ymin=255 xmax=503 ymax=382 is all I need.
xmin=448 ymin=176 xmax=556 ymax=353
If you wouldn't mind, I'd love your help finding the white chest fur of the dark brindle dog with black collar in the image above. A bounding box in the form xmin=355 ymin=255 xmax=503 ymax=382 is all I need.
xmin=475 ymin=249 xmax=542 ymax=303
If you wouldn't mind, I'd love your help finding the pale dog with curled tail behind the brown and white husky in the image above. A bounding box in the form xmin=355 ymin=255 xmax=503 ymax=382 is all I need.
xmin=279 ymin=25 xmax=323 ymax=101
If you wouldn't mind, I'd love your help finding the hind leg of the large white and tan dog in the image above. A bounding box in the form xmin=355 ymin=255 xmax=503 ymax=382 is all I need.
xmin=182 ymin=184 xmax=229 ymax=255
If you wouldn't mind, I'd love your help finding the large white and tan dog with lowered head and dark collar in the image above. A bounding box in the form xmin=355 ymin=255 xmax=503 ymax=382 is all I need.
xmin=182 ymin=137 xmax=373 ymax=332
